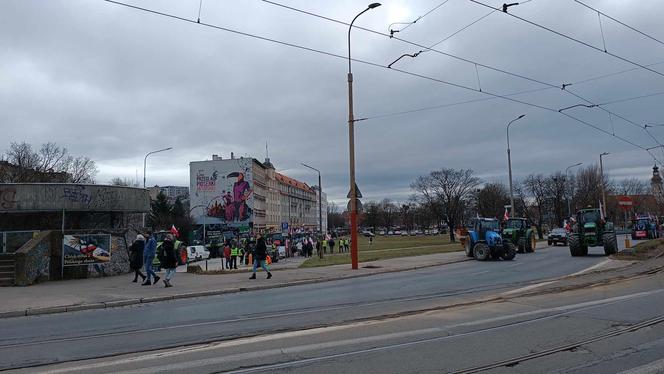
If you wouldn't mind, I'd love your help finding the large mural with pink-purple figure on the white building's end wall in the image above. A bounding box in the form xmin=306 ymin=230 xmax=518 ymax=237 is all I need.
xmin=190 ymin=158 xmax=254 ymax=228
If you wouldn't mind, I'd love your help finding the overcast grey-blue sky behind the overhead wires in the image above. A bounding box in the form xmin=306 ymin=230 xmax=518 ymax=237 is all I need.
xmin=0 ymin=0 xmax=664 ymax=202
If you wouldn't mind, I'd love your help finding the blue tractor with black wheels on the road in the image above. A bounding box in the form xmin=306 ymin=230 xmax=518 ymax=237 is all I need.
xmin=465 ymin=218 xmax=516 ymax=261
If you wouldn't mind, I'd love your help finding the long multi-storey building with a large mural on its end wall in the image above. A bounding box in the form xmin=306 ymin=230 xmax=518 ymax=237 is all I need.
xmin=190 ymin=155 xmax=327 ymax=231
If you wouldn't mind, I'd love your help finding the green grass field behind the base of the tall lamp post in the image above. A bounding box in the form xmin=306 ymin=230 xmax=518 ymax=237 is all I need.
xmin=300 ymin=235 xmax=463 ymax=268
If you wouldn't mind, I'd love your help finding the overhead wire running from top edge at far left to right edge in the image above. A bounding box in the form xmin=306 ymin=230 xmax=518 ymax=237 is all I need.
xmin=103 ymin=0 xmax=661 ymax=164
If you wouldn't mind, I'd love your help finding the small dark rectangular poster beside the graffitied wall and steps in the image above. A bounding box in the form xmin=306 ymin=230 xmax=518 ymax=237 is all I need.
xmin=62 ymin=234 xmax=111 ymax=266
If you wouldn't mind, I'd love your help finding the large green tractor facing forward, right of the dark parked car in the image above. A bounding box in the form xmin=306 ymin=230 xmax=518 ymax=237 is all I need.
xmin=568 ymin=208 xmax=618 ymax=256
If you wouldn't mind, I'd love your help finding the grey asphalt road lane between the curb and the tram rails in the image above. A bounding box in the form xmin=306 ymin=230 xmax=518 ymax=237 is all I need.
xmin=0 ymin=243 xmax=640 ymax=372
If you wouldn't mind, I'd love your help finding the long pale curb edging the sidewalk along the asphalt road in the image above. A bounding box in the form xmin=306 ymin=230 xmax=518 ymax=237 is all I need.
xmin=0 ymin=258 xmax=472 ymax=319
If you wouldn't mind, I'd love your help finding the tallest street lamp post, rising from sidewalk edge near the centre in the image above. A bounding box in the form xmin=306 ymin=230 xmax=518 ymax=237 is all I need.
xmin=348 ymin=3 xmax=380 ymax=270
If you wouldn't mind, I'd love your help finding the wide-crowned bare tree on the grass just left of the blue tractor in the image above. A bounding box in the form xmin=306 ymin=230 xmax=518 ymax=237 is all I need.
xmin=410 ymin=168 xmax=480 ymax=242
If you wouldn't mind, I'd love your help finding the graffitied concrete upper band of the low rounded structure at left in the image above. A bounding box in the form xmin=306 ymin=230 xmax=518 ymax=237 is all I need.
xmin=0 ymin=183 xmax=150 ymax=212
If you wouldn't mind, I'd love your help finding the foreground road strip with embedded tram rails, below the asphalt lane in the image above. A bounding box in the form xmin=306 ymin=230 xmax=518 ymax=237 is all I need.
xmin=26 ymin=279 xmax=664 ymax=374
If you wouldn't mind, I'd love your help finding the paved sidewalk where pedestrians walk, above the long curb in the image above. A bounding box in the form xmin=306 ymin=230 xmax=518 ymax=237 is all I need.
xmin=0 ymin=252 xmax=469 ymax=318
